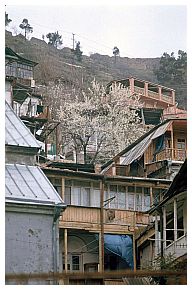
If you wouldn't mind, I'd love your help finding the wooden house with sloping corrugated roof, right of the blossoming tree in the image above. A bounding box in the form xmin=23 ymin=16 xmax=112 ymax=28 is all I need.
xmin=102 ymin=119 xmax=187 ymax=180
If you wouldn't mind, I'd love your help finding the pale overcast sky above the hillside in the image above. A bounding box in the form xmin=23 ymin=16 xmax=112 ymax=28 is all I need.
xmin=5 ymin=0 xmax=187 ymax=58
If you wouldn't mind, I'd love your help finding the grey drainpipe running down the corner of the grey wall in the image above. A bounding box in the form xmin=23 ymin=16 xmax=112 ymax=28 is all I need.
xmin=52 ymin=203 xmax=66 ymax=285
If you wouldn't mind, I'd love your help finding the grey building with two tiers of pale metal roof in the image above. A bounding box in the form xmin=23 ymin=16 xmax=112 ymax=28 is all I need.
xmin=5 ymin=102 xmax=66 ymax=284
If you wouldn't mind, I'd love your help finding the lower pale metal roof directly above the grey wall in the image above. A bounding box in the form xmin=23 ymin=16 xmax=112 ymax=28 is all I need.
xmin=5 ymin=164 xmax=63 ymax=204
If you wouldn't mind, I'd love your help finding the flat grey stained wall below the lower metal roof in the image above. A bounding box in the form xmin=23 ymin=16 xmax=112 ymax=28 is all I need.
xmin=5 ymin=210 xmax=53 ymax=274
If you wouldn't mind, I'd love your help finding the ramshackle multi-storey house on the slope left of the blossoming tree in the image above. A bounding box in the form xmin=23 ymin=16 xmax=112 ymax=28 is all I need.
xmin=5 ymin=47 xmax=59 ymax=155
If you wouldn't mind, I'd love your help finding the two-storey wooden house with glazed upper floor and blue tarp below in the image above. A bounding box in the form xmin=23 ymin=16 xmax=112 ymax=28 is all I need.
xmin=41 ymin=162 xmax=170 ymax=284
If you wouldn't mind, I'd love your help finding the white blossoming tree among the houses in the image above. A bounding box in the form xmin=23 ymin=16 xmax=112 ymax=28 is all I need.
xmin=51 ymin=81 xmax=145 ymax=163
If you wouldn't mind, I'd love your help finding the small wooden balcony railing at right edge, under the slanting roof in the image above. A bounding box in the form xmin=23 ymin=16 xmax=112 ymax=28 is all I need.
xmin=156 ymin=148 xmax=187 ymax=161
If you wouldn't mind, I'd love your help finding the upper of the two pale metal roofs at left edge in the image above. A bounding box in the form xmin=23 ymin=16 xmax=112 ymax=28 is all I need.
xmin=5 ymin=102 xmax=40 ymax=148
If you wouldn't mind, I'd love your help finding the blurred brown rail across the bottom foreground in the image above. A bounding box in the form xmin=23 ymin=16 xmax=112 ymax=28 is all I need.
xmin=5 ymin=270 xmax=187 ymax=285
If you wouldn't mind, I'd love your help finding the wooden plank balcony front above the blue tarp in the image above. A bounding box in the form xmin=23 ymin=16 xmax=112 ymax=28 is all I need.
xmin=59 ymin=205 xmax=149 ymax=234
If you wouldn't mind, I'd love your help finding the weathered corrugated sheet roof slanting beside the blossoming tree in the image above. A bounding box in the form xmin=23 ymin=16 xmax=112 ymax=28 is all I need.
xmin=120 ymin=121 xmax=172 ymax=165
